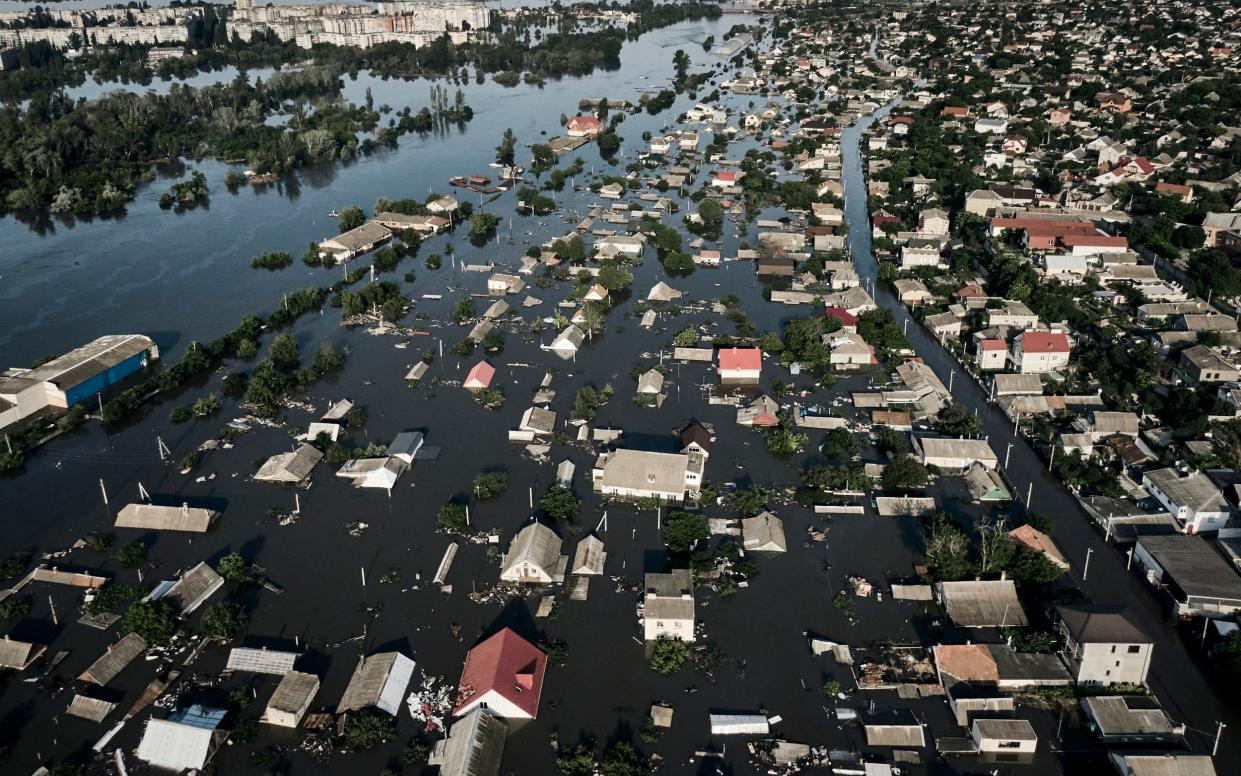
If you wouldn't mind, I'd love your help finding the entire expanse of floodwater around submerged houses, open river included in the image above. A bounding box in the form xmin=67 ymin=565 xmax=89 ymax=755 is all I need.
xmin=0 ymin=16 xmax=1226 ymax=775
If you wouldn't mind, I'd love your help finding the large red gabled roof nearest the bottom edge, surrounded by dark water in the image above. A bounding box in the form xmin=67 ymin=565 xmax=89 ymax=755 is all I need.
xmin=453 ymin=628 xmax=547 ymax=718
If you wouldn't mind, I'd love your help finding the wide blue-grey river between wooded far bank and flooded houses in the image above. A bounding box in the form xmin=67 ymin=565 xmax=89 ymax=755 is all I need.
xmin=0 ymin=15 xmax=734 ymax=365
